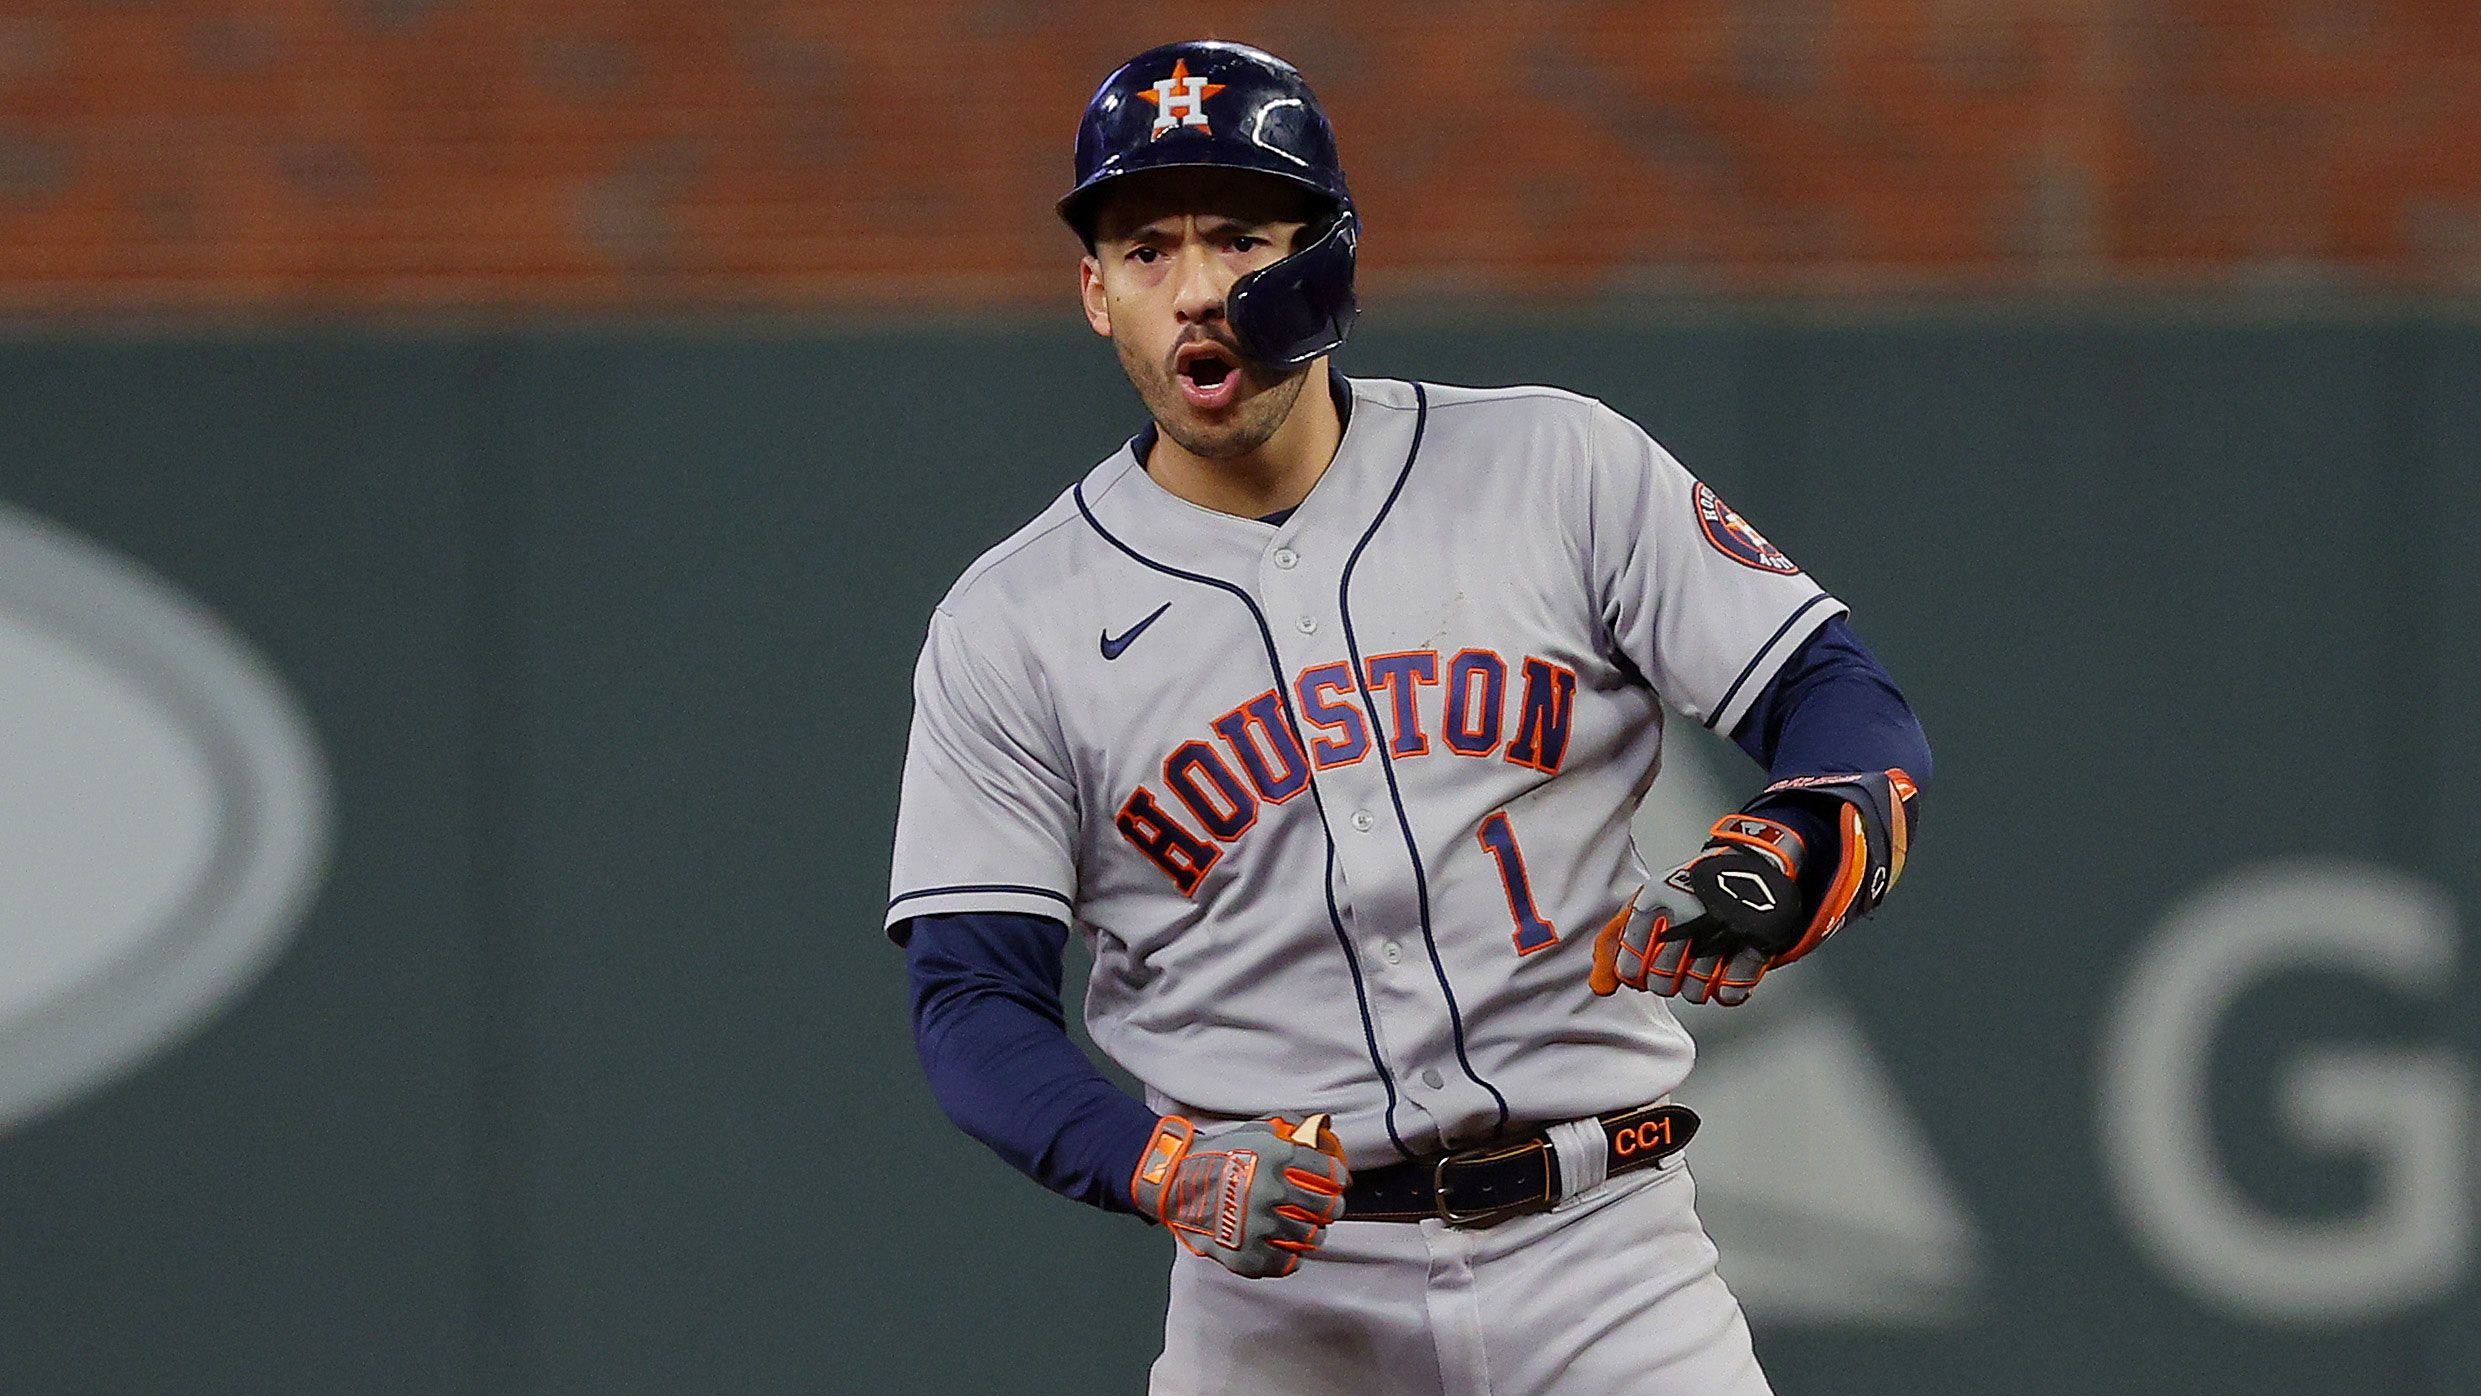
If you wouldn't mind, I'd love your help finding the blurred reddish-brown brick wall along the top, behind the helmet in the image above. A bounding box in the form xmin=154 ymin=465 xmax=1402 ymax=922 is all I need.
xmin=0 ymin=0 xmax=2481 ymax=312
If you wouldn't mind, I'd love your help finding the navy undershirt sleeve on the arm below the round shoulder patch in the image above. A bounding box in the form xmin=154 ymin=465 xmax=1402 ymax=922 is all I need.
xmin=1732 ymin=615 xmax=1930 ymax=903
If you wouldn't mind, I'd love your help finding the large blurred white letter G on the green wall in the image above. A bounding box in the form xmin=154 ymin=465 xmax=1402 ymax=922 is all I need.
xmin=2099 ymin=863 xmax=2471 ymax=1322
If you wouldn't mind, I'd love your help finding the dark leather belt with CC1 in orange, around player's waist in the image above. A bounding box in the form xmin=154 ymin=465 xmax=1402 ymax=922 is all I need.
xmin=1342 ymin=1103 xmax=1697 ymax=1227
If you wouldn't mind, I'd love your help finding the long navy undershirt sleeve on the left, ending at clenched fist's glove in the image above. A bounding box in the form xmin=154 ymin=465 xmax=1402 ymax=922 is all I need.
xmin=906 ymin=912 xmax=1156 ymax=1213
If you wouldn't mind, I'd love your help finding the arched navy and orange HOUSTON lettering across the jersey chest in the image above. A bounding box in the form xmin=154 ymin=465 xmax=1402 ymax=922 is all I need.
xmin=1114 ymin=650 xmax=1575 ymax=895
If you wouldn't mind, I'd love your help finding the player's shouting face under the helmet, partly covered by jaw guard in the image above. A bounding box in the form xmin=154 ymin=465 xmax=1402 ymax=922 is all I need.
xmin=1079 ymin=171 xmax=1310 ymax=459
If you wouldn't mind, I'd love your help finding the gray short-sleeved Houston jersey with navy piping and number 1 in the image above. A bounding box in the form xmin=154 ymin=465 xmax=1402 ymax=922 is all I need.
xmin=888 ymin=379 xmax=1843 ymax=1168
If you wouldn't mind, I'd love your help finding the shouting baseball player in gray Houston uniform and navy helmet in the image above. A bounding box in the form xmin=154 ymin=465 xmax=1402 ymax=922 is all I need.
xmin=886 ymin=42 xmax=1930 ymax=1396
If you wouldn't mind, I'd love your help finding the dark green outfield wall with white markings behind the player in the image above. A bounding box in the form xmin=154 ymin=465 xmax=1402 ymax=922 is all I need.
xmin=0 ymin=307 xmax=2481 ymax=1396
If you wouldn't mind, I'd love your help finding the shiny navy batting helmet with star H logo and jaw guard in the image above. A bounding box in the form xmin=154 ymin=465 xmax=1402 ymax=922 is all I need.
xmin=1059 ymin=40 xmax=1362 ymax=367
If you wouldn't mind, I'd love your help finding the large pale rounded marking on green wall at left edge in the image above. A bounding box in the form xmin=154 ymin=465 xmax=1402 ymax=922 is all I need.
xmin=0 ymin=506 xmax=330 ymax=1128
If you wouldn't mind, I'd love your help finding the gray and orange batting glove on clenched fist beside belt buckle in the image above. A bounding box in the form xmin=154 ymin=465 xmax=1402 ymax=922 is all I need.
xmin=1129 ymin=1116 xmax=1352 ymax=1279
